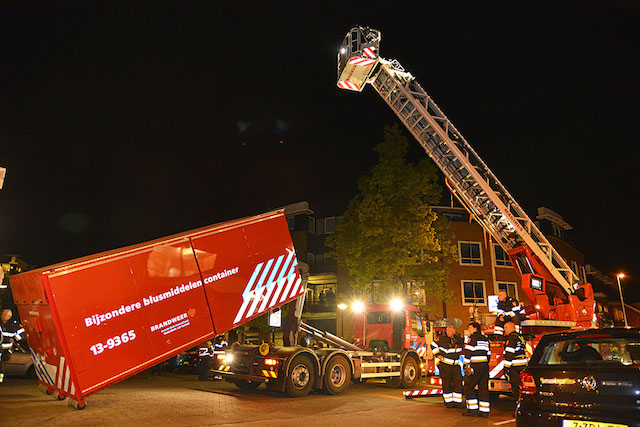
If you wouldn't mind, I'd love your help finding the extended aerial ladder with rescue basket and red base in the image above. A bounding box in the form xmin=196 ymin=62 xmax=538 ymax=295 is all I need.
xmin=337 ymin=26 xmax=594 ymax=326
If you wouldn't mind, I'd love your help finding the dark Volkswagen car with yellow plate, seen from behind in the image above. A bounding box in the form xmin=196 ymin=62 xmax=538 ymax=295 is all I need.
xmin=516 ymin=328 xmax=640 ymax=427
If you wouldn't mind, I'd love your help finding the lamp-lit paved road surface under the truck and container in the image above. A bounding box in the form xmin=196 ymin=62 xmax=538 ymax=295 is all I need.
xmin=0 ymin=372 xmax=515 ymax=427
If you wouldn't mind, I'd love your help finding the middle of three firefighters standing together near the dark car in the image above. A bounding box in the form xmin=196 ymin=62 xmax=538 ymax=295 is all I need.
xmin=462 ymin=322 xmax=491 ymax=418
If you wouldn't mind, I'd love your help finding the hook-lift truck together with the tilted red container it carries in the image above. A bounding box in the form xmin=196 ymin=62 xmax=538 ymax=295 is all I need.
xmin=10 ymin=210 xmax=440 ymax=409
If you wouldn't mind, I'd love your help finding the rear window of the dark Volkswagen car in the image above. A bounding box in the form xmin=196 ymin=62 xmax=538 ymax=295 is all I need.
xmin=538 ymin=335 xmax=640 ymax=366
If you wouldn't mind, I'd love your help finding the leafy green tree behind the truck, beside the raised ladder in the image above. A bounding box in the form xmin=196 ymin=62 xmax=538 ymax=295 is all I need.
xmin=327 ymin=125 xmax=456 ymax=309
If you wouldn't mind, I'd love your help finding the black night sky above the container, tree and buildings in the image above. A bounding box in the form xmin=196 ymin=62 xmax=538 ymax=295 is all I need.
xmin=0 ymin=0 xmax=640 ymax=299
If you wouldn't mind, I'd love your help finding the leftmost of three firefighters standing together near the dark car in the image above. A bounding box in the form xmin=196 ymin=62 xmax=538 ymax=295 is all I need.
xmin=431 ymin=325 xmax=464 ymax=408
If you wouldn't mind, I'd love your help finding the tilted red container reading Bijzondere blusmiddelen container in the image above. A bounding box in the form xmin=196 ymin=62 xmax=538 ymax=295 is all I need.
xmin=10 ymin=211 xmax=304 ymax=406
